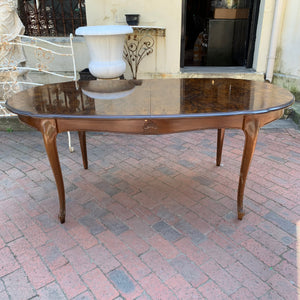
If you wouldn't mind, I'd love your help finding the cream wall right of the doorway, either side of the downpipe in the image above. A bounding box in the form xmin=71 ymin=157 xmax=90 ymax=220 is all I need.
xmin=253 ymin=0 xmax=300 ymax=91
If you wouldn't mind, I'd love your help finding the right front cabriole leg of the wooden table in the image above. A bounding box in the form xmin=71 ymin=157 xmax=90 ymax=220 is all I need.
xmin=237 ymin=117 xmax=259 ymax=220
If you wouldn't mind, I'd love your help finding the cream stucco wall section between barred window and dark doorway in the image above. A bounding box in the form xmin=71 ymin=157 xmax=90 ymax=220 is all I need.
xmin=86 ymin=0 xmax=182 ymax=75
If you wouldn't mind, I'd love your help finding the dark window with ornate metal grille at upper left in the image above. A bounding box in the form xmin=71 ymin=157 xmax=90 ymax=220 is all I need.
xmin=18 ymin=0 xmax=86 ymax=36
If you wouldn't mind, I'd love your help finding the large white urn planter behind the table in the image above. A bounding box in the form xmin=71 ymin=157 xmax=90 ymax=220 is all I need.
xmin=75 ymin=25 xmax=133 ymax=79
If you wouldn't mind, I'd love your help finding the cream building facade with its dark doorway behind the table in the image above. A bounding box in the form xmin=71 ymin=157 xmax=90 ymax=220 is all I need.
xmin=13 ymin=0 xmax=300 ymax=93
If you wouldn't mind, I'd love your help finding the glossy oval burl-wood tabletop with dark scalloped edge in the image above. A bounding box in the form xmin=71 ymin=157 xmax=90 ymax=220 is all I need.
xmin=6 ymin=79 xmax=294 ymax=119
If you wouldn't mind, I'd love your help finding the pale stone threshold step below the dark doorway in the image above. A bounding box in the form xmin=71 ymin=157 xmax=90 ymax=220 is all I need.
xmin=180 ymin=66 xmax=264 ymax=81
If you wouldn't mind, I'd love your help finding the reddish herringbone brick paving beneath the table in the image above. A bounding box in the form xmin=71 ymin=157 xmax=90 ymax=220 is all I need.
xmin=0 ymin=122 xmax=300 ymax=300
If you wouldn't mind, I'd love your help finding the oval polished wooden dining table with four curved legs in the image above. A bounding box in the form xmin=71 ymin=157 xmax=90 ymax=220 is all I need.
xmin=6 ymin=78 xmax=294 ymax=223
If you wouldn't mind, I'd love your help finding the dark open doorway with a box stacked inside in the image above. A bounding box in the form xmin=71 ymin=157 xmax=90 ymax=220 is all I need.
xmin=181 ymin=0 xmax=260 ymax=67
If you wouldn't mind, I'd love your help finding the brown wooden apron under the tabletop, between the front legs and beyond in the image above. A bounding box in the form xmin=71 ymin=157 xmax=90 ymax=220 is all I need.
xmin=18 ymin=109 xmax=284 ymax=134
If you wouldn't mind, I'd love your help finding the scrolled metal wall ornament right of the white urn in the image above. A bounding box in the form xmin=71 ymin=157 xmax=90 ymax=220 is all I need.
xmin=123 ymin=31 xmax=154 ymax=79
